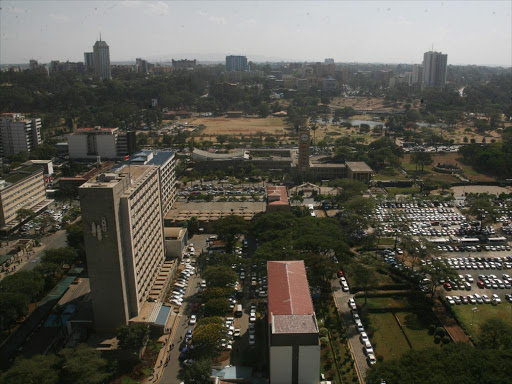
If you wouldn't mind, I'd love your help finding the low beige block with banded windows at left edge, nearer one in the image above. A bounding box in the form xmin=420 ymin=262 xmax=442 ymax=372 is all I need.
xmin=0 ymin=165 xmax=50 ymax=231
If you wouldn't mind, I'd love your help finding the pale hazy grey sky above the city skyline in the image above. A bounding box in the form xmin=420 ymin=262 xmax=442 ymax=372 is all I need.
xmin=0 ymin=0 xmax=512 ymax=66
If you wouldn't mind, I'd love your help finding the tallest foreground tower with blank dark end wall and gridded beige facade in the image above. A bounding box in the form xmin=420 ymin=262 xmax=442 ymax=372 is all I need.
xmin=79 ymin=165 xmax=165 ymax=331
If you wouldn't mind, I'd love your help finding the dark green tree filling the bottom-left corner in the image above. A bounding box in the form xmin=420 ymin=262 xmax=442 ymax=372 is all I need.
xmin=0 ymin=355 xmax=59 ymax=384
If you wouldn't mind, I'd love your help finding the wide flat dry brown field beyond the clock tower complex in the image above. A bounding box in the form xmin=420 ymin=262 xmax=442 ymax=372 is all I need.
xmin=187 ymin=117 xmax=291 ymax=136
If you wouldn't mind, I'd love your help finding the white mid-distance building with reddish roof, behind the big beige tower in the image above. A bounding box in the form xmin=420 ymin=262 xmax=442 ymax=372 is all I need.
xmin=68 ymin=126 xmax=135 ymax=160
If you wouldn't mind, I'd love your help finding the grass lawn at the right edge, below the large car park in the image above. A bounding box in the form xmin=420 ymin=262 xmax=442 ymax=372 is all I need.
xmin=452 ymin=301 xmax=512 ymax=338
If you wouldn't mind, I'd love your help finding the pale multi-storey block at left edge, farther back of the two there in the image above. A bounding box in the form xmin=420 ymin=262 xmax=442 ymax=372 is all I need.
xmin=0 ymin=113 xmax=42 ymax=157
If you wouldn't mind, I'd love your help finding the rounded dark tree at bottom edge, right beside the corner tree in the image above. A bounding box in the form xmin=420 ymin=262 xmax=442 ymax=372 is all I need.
xmin=59 ymin=344 xmax=110 ymax=384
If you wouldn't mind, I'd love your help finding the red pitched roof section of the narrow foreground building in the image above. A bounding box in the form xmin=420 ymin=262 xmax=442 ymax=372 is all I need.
xmin=267 ymin=260 xmax=314 ymax=321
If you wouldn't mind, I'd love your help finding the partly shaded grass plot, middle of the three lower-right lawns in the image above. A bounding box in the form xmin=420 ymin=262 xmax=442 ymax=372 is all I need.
xmin=396 ymin=312 xmax=441 ymax=349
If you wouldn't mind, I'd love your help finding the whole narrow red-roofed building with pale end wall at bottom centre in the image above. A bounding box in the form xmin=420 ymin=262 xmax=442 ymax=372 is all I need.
xmin=267 ymin=261 xmax=320 ymax=384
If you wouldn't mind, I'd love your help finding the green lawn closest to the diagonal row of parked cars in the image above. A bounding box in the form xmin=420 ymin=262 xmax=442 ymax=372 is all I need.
xmin=367 ymin=313 xmax=410 ymax=360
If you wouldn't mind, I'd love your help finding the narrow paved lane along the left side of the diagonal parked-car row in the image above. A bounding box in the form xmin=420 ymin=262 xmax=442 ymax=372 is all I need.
xmin=331 ymin=279 xmax=368 ymax=384
